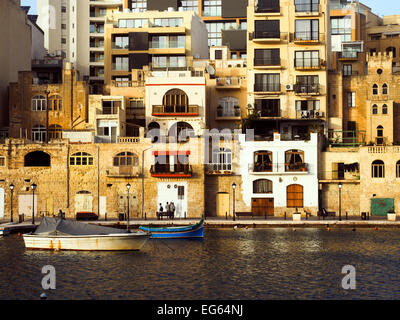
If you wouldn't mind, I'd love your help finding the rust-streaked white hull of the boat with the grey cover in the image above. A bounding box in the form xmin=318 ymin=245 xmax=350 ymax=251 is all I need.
xmin=23 ymin=232 xmax=150 ymax=251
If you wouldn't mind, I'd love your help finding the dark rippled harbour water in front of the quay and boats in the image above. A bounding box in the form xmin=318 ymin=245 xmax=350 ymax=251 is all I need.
xmin=0 ymin=228 xmax=400 ymax=300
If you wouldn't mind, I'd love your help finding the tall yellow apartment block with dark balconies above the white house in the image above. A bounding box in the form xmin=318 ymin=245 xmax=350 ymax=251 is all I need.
xmin=247 ymin=0 xmax=330 ymax=140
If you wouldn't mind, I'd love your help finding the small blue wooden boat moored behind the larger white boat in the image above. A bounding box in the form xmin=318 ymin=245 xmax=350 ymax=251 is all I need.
xmin=139 ymin=218 xmax=204 ymax=239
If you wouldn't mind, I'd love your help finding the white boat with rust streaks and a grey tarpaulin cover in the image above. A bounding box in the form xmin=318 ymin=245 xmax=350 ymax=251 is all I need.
xmin=23 ymin=217 xmax=150 ymax=251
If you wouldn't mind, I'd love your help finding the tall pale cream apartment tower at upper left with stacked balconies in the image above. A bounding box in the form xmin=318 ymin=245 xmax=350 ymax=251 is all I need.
xmin=37 ymin=0 xmax=123 ymax=93
